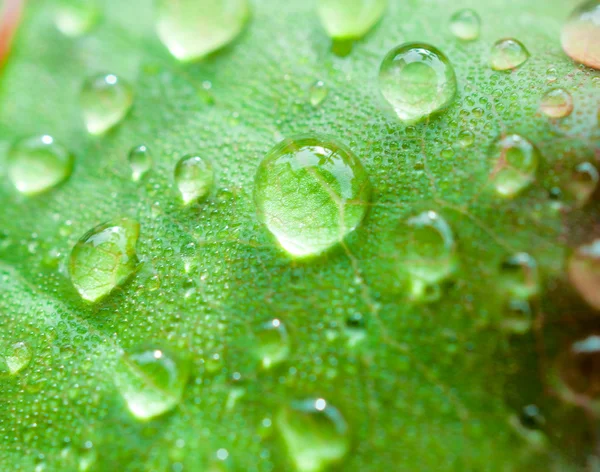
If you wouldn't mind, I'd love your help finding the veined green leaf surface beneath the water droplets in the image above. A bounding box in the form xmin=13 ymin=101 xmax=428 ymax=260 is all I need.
xmin=0 ymin=0 xmax=600 ymax=472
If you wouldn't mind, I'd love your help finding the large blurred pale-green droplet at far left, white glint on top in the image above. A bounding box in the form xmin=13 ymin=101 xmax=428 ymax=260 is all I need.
xmin=8 ymin=135 xmax=74 ymax=195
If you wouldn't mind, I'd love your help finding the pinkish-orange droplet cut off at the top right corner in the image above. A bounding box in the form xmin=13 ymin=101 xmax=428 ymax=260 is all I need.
xmin=561 ymin=0 xmax=600 ymax=69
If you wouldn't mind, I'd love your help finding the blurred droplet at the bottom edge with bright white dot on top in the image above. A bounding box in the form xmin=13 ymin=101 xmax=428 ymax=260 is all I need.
xmin=276 ymin=398 xmax=350 ymax=472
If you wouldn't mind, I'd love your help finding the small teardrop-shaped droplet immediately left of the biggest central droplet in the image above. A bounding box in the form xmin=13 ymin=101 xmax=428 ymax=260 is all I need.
xmin=175 ymin=156 xmax=215 ymax=205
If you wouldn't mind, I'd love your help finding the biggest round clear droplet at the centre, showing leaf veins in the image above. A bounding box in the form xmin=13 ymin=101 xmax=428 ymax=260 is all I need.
xmin=254 ymin=135 xmax=371 ymax=257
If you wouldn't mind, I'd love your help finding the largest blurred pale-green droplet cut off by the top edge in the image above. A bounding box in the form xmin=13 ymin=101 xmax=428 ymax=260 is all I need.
xmin=156 ymin=0 xmax=250 ymax=61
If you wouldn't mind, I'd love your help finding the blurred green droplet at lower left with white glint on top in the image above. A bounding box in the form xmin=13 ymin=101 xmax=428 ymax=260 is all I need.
xmin=115 ymin=348 xmax=190 ymax=421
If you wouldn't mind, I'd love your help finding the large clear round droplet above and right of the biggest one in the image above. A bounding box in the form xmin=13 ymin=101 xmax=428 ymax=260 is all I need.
xmin=379 ymin=43 xmax=457 ymax=123
